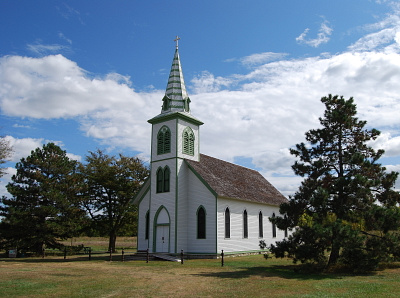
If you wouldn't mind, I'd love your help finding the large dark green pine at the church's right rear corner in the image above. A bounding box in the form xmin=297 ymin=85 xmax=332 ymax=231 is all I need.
xmin=270 ymin=95 xmax=400 ymax=270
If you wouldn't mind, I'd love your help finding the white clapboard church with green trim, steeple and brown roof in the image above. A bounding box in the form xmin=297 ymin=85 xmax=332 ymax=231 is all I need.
xmin=133 ymin=38 xmax=287 ymax=255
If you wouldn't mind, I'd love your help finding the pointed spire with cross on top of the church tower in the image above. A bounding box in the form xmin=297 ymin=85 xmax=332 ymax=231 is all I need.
xmin=161 ymin=36 xmax=190 ymax=113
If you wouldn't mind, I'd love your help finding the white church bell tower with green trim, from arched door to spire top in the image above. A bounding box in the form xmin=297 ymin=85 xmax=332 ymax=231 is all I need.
xmin=148 ymin=37 xmax=203 ymax=253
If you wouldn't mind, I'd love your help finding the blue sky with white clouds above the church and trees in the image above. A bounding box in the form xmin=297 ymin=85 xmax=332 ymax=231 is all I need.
xmin=0 ymin=0 xmax=400 ymax=195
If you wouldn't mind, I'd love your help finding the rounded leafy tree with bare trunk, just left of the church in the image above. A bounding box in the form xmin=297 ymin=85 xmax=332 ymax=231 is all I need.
xmin=81 ymin=150 xmax=149 ymax=252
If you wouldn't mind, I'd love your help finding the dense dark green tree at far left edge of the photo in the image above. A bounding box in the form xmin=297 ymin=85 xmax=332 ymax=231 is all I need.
xmin=0 ymin=143 xmax=85 ymax=253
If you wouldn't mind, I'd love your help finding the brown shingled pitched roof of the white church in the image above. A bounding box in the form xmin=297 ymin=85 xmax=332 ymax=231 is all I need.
xmin=186 ymin=154 xmax=287 ymax=205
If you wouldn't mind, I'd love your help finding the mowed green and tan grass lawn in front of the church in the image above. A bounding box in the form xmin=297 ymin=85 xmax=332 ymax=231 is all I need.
xmin=0 ymin=239 xmax=400 ymax=297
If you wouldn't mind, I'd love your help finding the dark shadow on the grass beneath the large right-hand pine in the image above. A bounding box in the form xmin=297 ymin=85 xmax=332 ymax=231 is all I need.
xmin=194 ymin=265 xmax=376 ymax=280
